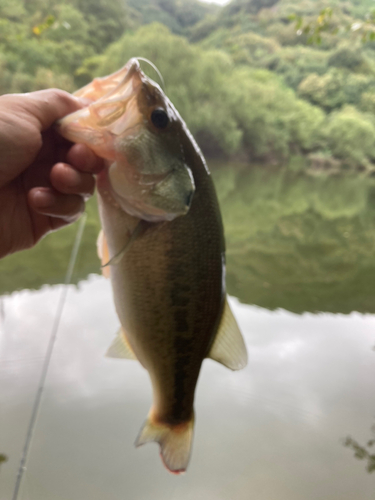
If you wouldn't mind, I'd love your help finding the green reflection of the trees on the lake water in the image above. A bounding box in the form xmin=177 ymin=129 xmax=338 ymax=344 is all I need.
xmin=0 ymin=165 xmax=375 ymax=314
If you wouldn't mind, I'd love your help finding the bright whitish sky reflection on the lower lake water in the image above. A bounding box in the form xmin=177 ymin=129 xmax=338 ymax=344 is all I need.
xmin=0 ymin=276 xmax=375 ymax=500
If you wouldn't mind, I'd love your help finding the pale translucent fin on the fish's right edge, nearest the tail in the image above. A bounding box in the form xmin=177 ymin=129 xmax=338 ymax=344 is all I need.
xmin=207 ymin=299 xmax=247 ymax=370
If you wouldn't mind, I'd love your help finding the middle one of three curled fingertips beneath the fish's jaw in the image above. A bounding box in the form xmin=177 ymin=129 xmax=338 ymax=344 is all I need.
xmin=50 ymin=163 xmax=95 ymax=198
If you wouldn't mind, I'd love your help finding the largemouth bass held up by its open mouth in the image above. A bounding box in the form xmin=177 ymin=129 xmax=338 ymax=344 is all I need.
xmin=57 ymin=58 xmax=247 ymax=474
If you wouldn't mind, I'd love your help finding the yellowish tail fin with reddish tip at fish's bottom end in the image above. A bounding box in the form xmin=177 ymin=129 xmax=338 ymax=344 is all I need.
xmin=135 ymin=416 xmax=194 ymax=474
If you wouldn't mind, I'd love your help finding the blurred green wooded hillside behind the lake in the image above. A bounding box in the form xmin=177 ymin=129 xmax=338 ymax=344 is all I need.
xmin=0 ymin=0 xmax=375 ymax=168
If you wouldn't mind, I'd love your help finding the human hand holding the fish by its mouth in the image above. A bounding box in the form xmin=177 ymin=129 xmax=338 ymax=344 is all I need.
xmin=0 ymin=89 xmax=103 ymax=258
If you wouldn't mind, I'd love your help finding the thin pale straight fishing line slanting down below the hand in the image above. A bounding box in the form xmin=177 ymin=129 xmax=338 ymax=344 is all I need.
xmin=12 ymin=214 xmax=87 ymax=500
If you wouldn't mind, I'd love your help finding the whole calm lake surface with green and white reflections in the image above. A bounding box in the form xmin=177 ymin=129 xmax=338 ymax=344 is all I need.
xmin=0 ymin=165 xmax=375 ymax=500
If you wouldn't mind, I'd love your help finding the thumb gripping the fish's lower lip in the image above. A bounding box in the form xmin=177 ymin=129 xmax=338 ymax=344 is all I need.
xmin=22 ymin=89 xmax=83 ymax=131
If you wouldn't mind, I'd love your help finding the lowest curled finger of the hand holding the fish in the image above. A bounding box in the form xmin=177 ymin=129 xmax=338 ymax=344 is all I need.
xmin=28 ymin=188 xmax=85 ymax=222
